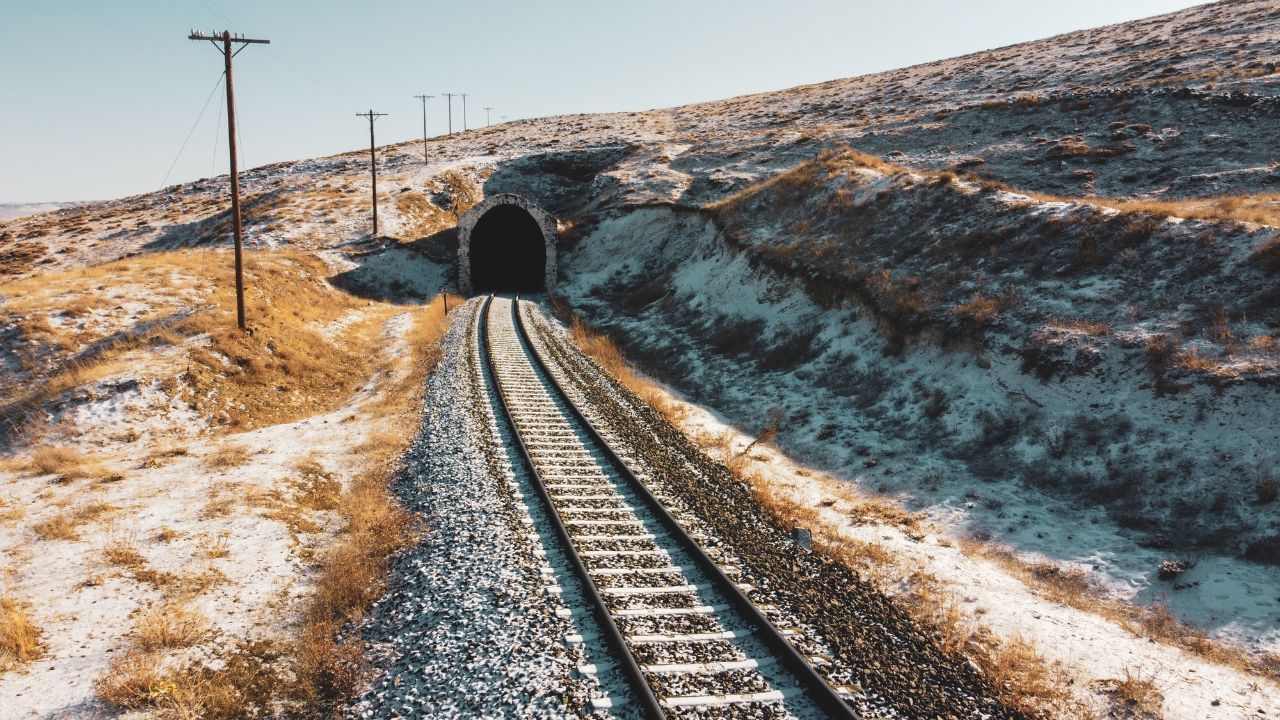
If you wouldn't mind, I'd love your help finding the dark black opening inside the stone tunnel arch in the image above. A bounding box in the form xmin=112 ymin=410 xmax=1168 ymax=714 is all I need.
xmin=471 ymin=205 xmax=547 ymax=292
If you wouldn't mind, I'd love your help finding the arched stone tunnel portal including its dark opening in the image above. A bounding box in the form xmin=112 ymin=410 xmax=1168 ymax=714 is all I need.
xmin=458 ymin=193 xmax=556 ymax=293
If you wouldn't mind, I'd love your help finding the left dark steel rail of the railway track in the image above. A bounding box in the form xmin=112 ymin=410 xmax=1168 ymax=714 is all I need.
xmin=479 ymin=295 xmax=667 ymax=720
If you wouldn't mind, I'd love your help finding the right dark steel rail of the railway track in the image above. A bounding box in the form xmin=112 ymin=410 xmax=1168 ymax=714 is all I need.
xmin=509 ymin=297 xmax=858 ymax=720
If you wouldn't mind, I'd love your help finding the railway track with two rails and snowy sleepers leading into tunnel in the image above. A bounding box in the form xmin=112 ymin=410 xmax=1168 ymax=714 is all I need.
xmin=476 ymin=297 xmax=855 ymax=717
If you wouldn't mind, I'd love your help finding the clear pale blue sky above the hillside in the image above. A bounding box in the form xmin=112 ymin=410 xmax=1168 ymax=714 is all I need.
xmin=0 ymin=0 xmax=1198 ymax=202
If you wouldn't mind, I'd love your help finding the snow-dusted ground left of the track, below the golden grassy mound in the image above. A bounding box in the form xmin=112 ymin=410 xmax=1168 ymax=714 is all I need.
xmin=0 ymin=284 xmax=435 ymax=719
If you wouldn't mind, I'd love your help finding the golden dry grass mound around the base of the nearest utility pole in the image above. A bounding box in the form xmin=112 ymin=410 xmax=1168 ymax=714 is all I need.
xmin=0 ymin=250 xmax=390 ymax=430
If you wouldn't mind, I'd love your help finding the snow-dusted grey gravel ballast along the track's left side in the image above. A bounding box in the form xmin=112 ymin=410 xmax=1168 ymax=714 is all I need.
xmin=347 ymin=302 xmax=616 ymax=717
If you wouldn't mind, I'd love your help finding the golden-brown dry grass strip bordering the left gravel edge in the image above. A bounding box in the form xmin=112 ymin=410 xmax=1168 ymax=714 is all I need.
xmin=95 ymin=294 xmax=445 ymax=720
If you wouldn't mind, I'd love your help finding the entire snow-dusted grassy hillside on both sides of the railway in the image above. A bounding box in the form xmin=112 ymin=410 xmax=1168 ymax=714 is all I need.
xmin=0 ymin=0 xmax=1280 ymax=717
